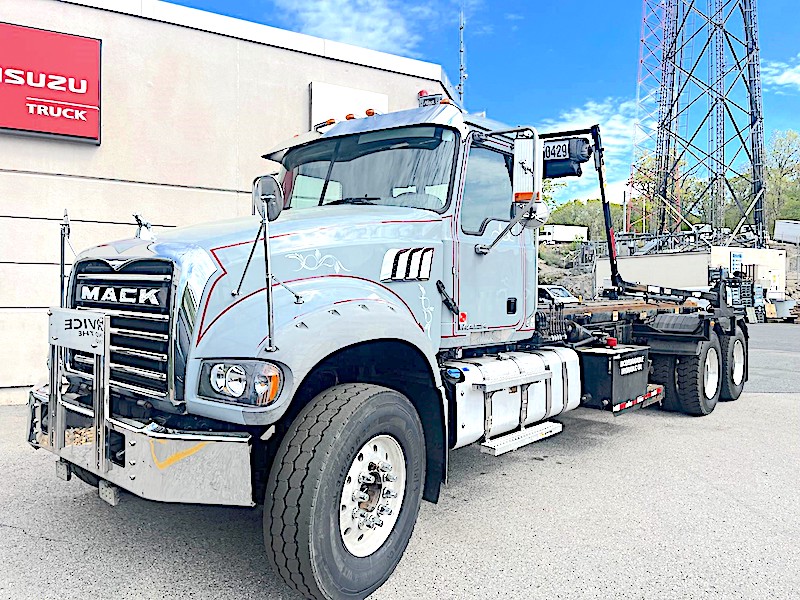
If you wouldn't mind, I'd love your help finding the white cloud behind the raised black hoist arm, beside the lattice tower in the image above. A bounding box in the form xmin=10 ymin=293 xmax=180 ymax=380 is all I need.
xmin=539 ymin=98 xmax=636 ymax=202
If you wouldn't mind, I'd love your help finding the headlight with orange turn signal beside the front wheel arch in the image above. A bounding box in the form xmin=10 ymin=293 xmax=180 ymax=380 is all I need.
xmin=197 ymin=360 xmax=283 ymax=406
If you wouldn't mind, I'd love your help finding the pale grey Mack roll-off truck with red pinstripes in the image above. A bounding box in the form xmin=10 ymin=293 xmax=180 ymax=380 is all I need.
xmin=26 ymin=103 xmax=748 ymax=599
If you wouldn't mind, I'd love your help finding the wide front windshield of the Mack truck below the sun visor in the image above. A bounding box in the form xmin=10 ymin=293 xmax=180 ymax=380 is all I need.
xmin=281 ymin=125 xmax=457 ymax=210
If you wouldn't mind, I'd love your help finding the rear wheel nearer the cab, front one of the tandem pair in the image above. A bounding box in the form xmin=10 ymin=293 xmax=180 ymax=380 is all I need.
xmin=676 ymin=332 xmax=723 ymax=417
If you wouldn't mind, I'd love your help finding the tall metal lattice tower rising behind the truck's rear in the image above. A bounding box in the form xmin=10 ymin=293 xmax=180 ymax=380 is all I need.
xmin=630 ymin=0 xmax=765 ymax=246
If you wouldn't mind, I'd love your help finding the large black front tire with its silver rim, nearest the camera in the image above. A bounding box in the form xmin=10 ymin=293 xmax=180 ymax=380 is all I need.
xmin=264 ymin=383 xmax=425 ymax=600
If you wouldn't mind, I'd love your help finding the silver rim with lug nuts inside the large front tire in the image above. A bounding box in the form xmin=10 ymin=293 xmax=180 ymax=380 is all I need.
xmin=339 ymin=434 xmax=406 ymax=558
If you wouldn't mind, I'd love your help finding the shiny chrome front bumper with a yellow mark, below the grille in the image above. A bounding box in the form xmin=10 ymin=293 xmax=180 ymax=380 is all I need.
xmin=27 ymin=390 xmax=254 ymax=506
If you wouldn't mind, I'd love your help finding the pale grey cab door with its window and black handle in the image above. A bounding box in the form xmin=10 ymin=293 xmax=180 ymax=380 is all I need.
xmin=454 ymin=140 xmax=525 ymax=336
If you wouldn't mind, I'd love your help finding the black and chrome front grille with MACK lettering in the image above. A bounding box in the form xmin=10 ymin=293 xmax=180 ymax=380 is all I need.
xmin=68 ymin=260 xmax=173 ymax=398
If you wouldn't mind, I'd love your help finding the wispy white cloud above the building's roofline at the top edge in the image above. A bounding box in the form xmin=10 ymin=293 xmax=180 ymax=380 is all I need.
xmin=273 ymin=0 xmax=480 ymax=58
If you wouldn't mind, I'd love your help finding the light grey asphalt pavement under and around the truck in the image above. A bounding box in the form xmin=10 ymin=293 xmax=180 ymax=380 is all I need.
xmin=0 ymin=324 xmax=800 ymax=600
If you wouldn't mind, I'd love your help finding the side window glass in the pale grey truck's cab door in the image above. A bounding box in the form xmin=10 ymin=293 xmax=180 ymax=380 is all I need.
xmin=461 ymin=146 xmax=512 ymax=235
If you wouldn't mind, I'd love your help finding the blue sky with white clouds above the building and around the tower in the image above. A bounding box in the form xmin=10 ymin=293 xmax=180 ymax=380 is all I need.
xmin=170 ymin=0 xmax=800 ymax=202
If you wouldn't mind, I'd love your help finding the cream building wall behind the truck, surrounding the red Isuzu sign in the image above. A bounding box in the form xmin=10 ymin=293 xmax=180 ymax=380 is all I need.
xmin=0 ymin=0 xmax=449 ymax=387
